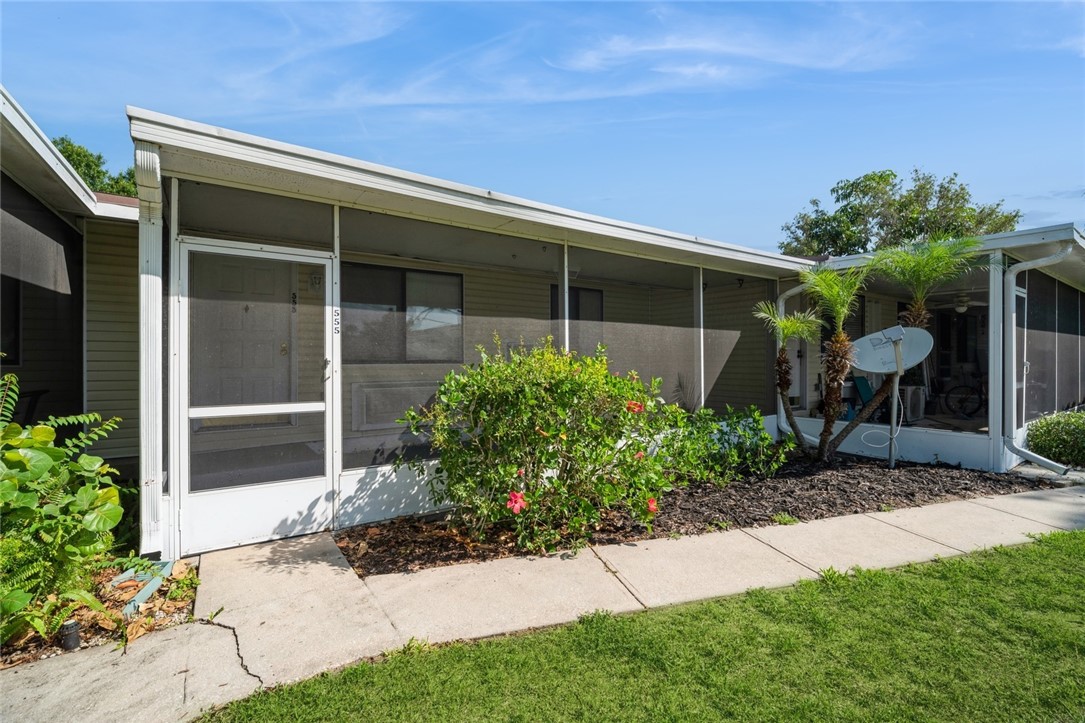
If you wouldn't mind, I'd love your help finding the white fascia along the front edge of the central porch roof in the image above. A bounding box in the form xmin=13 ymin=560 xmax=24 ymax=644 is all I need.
xmin=127 ymin=106 xmax=810 ymax=272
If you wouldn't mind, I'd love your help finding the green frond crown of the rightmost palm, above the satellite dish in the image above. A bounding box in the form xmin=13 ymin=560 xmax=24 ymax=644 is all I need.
xmin=871 ymin=237 xmax=981 ymax=329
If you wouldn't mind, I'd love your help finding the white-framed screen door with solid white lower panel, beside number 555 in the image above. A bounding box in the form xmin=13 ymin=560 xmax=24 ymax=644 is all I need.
xmin=174 ymin=239 xmax=333 ymax=555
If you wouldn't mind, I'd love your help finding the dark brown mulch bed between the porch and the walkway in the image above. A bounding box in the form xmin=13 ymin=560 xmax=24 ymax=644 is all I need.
xmin=336 ymin=456 xmax=1051 ymax=578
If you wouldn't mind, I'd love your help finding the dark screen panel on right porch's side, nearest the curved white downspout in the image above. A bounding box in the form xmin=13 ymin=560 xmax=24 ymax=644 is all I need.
xmin=1024 ymin=269 xmax=1058 ymax=421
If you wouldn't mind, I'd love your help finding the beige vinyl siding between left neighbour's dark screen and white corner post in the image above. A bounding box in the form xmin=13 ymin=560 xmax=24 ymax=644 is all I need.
xmin=86 ymin=221 xmax=139 ymax=459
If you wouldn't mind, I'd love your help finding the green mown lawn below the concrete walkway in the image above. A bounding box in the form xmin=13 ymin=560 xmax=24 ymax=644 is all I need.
xmin=208 ymin=531 xmax=1085 ymax=722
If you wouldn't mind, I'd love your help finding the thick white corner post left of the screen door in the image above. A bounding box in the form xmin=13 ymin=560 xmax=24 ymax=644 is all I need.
xmin=136 ymin=140 xmax=162 ymax=557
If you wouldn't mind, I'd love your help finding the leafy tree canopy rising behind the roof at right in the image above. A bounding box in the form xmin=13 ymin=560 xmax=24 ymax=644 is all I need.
xmin=780 ymin=168 xmax=1021 ymax=256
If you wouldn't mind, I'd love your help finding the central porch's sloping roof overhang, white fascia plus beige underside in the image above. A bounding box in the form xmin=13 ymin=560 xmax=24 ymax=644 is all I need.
xmin=128 ymin=106 xmax=810 ymax=278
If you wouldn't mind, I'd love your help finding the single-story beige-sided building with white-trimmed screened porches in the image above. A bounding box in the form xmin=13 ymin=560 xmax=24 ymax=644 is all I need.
xmin=0 ymin=85 xmax=1085 ymax=557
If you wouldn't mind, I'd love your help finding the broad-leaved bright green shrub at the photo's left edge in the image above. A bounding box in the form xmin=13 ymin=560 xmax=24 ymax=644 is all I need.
xmin=0 ymin=375 xmax=122 ymax=643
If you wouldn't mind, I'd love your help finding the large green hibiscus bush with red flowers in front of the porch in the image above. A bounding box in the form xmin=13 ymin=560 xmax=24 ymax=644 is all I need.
xmin=399 ymin=339 xmax=715 ymax=550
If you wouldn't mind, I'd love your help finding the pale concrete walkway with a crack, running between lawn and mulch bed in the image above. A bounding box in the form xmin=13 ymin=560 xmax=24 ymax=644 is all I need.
xmin=0 ymin=486 xmax=1085 ymax=722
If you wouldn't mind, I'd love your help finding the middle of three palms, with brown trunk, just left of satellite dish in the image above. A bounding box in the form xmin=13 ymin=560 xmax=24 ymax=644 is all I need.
xmin=800 ymin=261 xmax=869 ymax=461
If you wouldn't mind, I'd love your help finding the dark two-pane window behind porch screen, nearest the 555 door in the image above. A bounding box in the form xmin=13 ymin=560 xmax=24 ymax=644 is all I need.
xmin=340 ymin=263 xmax=463 ymax=364
